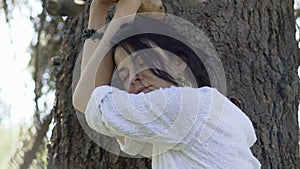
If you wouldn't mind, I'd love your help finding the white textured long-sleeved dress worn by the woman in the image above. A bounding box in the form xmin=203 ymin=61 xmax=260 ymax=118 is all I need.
xmin=85 ymin=86 xmax=261 ymax=169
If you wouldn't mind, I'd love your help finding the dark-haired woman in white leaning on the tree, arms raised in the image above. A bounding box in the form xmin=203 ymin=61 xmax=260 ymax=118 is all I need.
xmin=73 ymin=0 xmax=260 ymax=169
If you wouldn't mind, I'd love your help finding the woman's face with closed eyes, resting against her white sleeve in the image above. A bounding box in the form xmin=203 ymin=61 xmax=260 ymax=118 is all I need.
xmin=114 ymin=46 xmax=172 ymax=94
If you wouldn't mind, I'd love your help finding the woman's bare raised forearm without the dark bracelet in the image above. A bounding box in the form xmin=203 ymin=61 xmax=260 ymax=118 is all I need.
xmin=73 ymin=0 xmax=140 ymax=112
